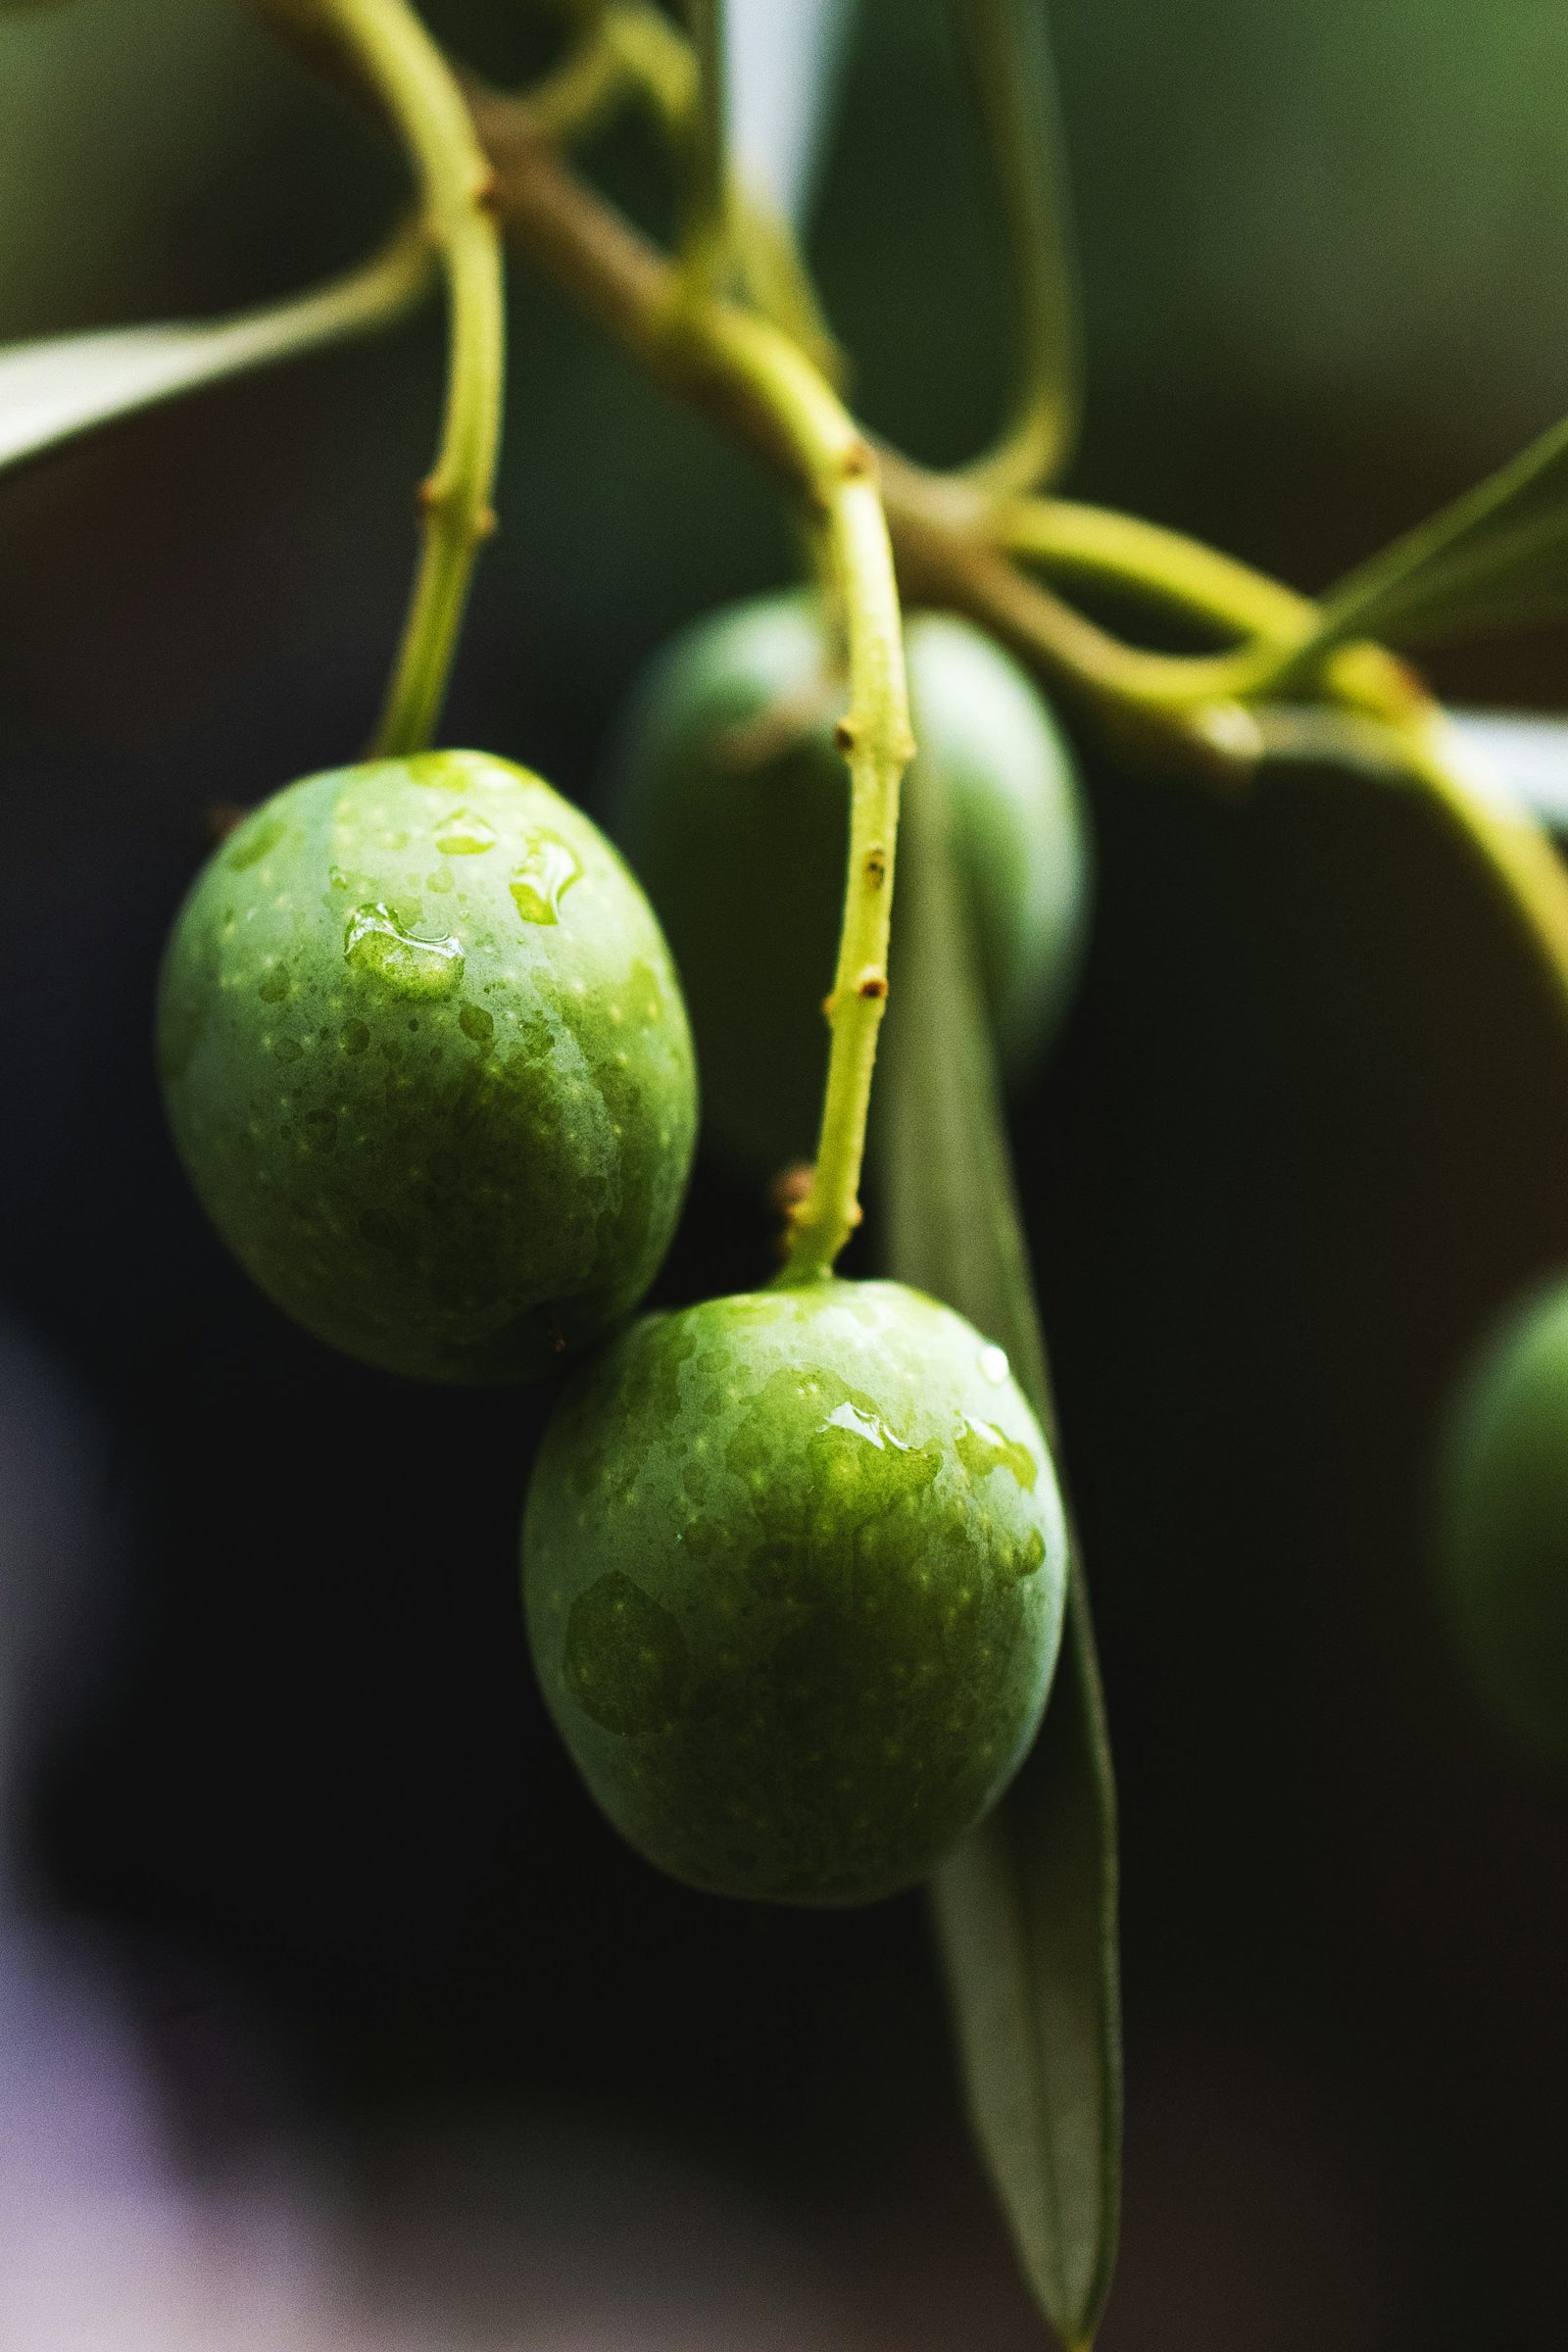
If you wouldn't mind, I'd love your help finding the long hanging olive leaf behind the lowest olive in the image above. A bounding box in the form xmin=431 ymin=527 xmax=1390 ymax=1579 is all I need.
xmin=879 ymin=743 xmax=1121 ymax=2347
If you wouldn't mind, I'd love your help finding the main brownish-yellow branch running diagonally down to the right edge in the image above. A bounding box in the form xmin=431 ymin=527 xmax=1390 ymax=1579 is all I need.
xmin=453 ymin=101 xmax=1568 ymax=1101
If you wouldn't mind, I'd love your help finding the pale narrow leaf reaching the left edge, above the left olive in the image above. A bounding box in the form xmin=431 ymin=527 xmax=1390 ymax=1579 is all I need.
xmin=0 ymin=223 xmax=435 ymax=468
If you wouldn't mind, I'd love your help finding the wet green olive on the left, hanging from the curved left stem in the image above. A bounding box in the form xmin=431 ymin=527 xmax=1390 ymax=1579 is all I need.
xmin=158 ymin=753 xmax=696 ymax=1381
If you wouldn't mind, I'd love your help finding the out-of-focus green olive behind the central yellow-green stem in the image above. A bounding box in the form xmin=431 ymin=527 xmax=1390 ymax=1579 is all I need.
xmin=613 ymin=593 xmax=1091 ymax=1171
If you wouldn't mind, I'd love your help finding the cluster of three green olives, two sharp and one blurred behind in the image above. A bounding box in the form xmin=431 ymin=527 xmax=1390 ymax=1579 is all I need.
xmin=158 ymin=598 xmax=1089 ymax=1903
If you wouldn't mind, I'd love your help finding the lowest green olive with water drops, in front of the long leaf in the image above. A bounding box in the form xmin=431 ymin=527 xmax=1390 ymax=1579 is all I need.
xmin=522 ymin=1282 xmax=1067 ymax=1903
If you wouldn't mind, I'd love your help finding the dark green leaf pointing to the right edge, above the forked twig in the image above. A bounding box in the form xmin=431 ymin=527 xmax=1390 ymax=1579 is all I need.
xmin=1284 ymin=418 xmax=1568 ymax=675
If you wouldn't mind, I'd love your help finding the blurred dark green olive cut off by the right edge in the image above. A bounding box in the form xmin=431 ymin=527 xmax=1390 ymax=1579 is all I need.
xmin=1441 ymin=1282 xmax=1568 ymax=1764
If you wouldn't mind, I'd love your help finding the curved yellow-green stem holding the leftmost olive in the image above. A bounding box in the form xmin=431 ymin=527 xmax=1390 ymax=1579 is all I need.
xmin=315 ymin=0 xmax=506 ymax=753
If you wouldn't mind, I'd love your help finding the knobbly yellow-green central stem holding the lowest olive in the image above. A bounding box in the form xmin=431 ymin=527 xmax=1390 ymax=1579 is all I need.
xmin=667 ymin=296 xmax=914 ymax=1284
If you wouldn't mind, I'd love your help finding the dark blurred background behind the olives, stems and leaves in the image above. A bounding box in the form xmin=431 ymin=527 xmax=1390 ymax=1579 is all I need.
xmin=0 ymin=0 xmax=1568 ymax=2352
